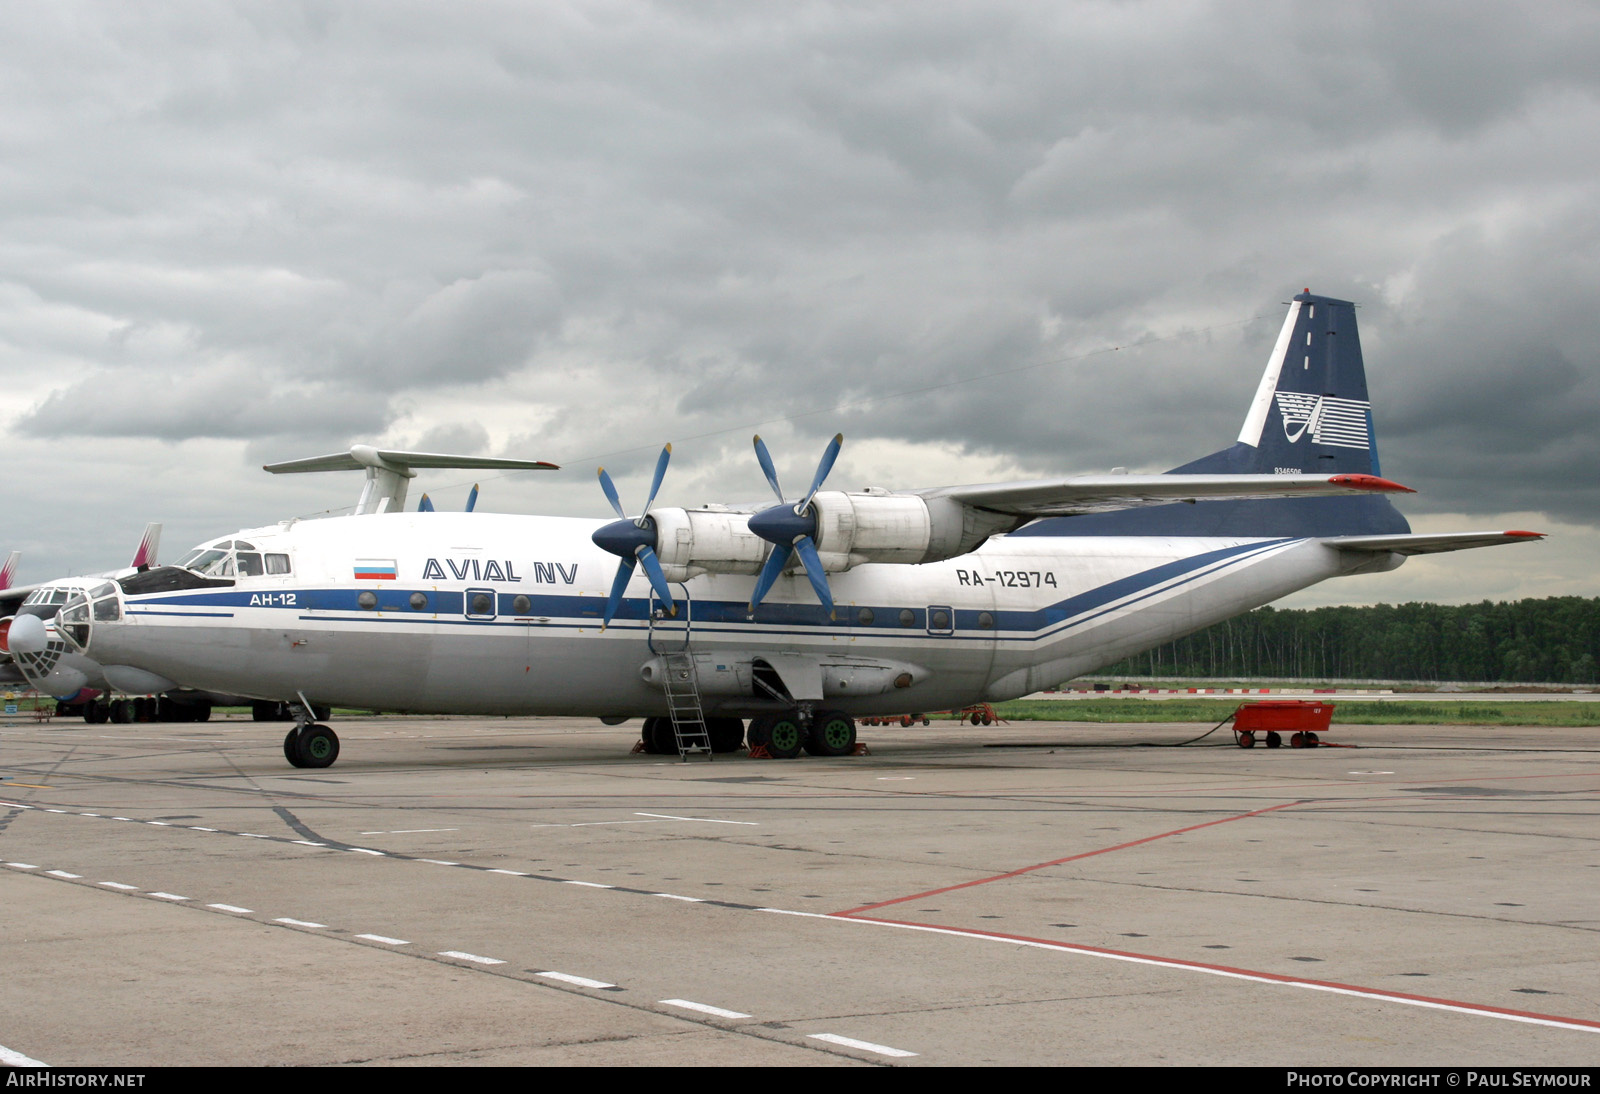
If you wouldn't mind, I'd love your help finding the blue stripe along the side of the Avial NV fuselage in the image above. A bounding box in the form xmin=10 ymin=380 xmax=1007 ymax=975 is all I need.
xmin=128 ymin=537 xmax=1298 ymax=641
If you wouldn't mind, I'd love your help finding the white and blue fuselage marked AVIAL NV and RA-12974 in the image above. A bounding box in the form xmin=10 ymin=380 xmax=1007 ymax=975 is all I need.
xmin=72 ymin=513 xmax=1376 ymax=717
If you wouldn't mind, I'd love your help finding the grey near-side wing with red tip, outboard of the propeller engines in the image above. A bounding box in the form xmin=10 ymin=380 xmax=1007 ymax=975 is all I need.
xmin=909 ymin=475 xmax=1416 ymax=520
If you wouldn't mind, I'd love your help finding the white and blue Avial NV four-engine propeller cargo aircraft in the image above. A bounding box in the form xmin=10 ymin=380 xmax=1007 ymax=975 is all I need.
xmin=37 ymin=291 xmax=1539 ymax=766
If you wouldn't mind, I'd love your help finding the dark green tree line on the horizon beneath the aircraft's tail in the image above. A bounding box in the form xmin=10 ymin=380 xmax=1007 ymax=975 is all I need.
xmin=1096 ymin=597 xmax=1600 ymax=685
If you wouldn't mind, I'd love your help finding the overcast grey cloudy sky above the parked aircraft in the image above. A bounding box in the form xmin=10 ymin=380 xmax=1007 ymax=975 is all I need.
xmin=0 ymin=0 xmax=1600 ymax=605
